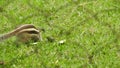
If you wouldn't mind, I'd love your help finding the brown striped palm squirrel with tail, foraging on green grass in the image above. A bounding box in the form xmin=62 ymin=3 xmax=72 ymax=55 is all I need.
xmin=0 ymin=24 xmax=42 ymax=43
